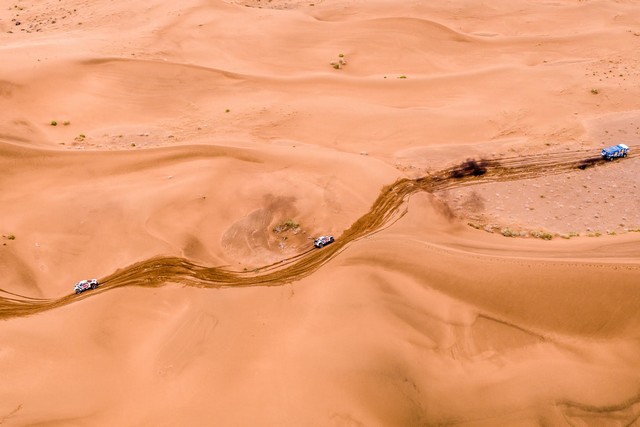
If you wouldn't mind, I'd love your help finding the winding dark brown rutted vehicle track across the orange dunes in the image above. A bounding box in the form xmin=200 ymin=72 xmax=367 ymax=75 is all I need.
xmin=0 ymin=146 xmax=640 ymax=319
